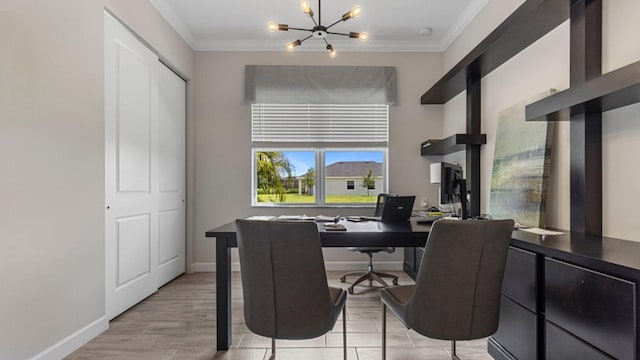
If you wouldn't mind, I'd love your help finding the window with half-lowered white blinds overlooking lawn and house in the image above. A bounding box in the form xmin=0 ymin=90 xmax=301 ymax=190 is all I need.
xmin=252 ymin=104 xmax=388 ymax=206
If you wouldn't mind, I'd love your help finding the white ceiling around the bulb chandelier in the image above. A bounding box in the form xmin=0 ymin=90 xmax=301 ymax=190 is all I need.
xmin=149 ymin=0 xmax=488 ymax=51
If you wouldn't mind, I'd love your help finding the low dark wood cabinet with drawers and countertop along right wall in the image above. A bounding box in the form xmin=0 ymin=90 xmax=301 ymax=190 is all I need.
xmin=488 ymin=231 xmax=640 ymax=360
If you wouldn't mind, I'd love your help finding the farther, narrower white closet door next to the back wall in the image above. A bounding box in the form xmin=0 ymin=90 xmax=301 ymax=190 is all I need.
xmin=158 ymin=65 xmax=186 ymax=287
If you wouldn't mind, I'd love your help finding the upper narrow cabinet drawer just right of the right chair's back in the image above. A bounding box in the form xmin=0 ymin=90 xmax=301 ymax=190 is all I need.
xmin=502 ymin=247 xmax=539 ymax=312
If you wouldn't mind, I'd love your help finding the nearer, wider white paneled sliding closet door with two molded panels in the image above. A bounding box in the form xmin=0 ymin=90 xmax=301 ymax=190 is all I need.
xmin=105 ymin=13 xmax=159 ymax=319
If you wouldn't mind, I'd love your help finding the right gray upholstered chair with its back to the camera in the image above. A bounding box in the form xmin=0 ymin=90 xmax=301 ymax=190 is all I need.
xmin=380 ymin=220 xmax=513 ymax=359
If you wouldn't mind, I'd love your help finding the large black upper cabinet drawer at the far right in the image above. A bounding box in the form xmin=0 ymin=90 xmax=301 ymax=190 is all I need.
xmin=545 ymin=259 xmax=636 ymax=359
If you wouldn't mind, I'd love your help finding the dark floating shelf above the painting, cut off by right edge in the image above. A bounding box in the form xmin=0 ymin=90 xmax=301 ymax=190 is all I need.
xmin=525 ymin=62 xmax=640 ymax=121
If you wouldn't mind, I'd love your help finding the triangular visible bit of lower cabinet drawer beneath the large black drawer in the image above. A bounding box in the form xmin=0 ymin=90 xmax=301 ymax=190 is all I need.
xmin=545 ymin=322 xmax=613 ymax=360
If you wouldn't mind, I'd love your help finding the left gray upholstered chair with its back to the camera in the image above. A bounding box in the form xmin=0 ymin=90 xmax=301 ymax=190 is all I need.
xmin=236 ymin=220 xmax=347 ymax=359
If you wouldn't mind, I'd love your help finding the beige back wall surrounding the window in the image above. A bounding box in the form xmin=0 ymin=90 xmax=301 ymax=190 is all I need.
xmin=194 ymin=51 xmax=442 ymax=270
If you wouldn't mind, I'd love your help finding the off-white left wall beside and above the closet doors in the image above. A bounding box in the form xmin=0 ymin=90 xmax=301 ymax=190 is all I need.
xmin=0 ymin=0 xmax=193 ymax=359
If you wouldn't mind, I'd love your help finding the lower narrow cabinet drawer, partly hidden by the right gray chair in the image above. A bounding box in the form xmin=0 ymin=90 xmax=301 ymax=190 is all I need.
xmin=492 ymin=296 xmax=538 ymax=360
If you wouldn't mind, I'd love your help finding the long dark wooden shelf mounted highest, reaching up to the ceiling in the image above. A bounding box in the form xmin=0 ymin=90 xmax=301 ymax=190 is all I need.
xmin=420 ymin=0 xmax=569 ymax=104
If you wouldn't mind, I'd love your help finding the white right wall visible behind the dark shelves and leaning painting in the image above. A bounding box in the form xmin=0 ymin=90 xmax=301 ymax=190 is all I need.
xmin=444 ymin=0 xmax=640 ymax=241
